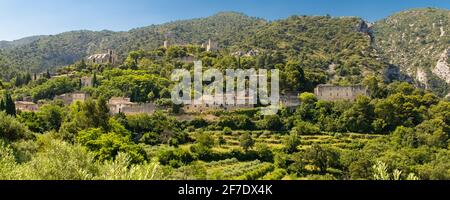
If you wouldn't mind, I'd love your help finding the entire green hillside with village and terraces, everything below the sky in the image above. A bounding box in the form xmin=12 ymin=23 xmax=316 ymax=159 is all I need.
xmin=0 ymin=8 xmax=450 ymax=180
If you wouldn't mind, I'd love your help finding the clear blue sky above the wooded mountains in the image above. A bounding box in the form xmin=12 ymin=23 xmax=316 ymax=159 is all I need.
xmin=0 ymin=0 xmax=450 ymax=40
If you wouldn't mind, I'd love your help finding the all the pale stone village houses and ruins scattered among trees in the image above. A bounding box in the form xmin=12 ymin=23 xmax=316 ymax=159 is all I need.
xmin=15 ymin=39 xmax=368 ymax=115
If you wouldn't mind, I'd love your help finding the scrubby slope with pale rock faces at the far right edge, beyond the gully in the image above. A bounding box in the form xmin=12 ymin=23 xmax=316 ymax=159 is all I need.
xmin=373 ymin=8 xmax=450 ymax=94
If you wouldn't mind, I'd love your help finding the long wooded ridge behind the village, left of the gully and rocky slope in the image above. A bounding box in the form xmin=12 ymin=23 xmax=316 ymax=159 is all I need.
xmin=0 ymin=12 xmax=385 ymax=84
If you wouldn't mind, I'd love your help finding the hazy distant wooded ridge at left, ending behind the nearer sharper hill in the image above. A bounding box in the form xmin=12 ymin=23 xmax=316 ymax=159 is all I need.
xmin=0 ymin=13 xmax=266 ymax=75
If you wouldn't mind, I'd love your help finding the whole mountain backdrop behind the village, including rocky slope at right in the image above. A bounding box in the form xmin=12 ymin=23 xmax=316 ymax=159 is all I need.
xmin=0 ymin=9 xmax=450 ymax=95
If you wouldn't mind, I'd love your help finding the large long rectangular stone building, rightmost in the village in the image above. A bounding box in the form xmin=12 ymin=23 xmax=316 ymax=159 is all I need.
xmin=314 ymin=85 xmax=368 ymax=101
